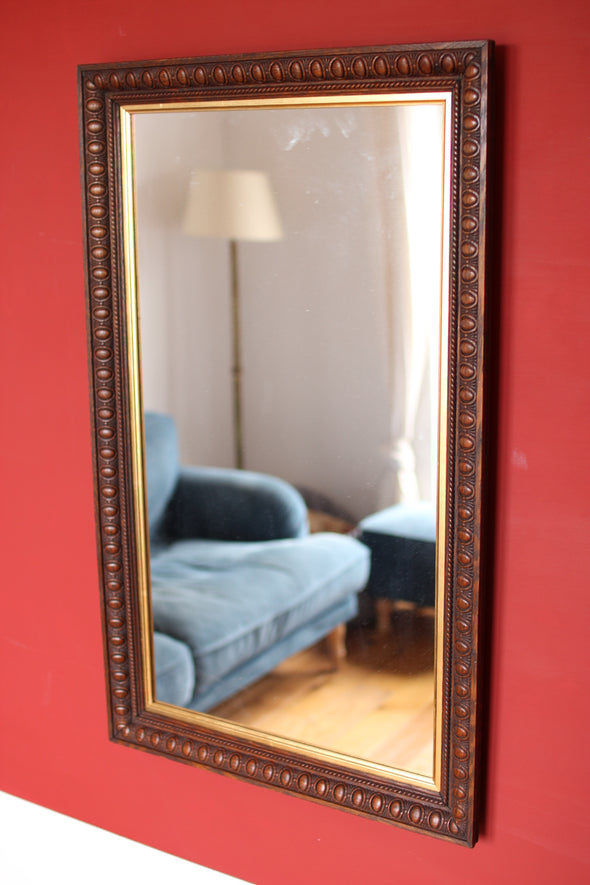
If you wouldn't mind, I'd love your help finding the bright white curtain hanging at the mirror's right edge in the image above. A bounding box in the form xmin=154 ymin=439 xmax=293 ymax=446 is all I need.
xmin=379 ymin=104 xmax=444 ymax=507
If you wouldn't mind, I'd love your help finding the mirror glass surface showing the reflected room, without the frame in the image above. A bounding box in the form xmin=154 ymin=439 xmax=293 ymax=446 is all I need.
xmin=133 ymin=93 xmax=450 ymax=779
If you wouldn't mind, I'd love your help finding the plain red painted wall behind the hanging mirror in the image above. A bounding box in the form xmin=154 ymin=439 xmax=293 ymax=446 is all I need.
xmin=0 ymin=0 xmax=590 ymax=885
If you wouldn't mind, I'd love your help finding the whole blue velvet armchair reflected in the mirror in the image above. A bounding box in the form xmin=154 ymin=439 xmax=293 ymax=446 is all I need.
xmin=145 ymin=412 xmax=370 ymax=711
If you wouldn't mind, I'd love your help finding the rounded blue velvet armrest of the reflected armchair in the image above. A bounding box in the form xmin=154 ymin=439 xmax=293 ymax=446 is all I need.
xmin=167 ymin=467 xmax=309 ymax=541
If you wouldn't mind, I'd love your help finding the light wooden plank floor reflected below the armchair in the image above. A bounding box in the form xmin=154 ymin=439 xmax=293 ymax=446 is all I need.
xmin=211 ymin=610 xmax=434 ymax=776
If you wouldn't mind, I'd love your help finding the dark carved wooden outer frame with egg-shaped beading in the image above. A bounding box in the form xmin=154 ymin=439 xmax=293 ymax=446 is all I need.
xmin=79 ymin=41 xmax=492 ymax=845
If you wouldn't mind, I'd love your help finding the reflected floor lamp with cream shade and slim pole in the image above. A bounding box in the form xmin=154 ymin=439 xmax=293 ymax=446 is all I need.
xmin=183 ymin=169 xmax=283 ymax=469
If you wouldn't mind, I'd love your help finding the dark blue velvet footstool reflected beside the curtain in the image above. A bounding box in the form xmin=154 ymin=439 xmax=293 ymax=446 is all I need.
xmin=357 ymin=501 xmax=436 ymax=629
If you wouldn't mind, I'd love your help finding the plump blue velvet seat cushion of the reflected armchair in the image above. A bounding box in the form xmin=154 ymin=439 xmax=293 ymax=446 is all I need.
xmin=151 ymin=534 xmax=369 ymax=693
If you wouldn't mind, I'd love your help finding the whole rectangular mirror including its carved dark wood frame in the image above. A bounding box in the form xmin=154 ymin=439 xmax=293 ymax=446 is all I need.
xmin=80 ymin=43 xmax=490 ymax=845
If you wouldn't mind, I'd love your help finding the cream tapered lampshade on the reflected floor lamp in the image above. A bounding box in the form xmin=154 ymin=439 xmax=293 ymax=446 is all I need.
xmin=183 ymin=169 xmax=283 ymax=242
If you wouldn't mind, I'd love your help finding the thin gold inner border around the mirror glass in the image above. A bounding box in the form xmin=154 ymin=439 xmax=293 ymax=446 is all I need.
xmin=119 ymin=90 xmax=453 ymax=791
